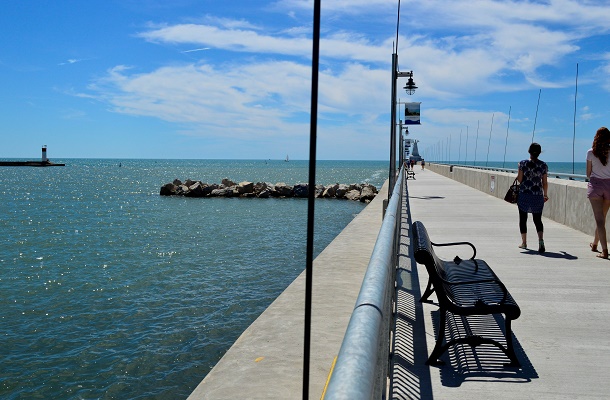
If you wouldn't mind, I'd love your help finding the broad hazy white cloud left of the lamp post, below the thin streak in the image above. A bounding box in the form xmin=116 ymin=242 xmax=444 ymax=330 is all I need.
xmin=86 ymin=61 xmax=388 ymax=140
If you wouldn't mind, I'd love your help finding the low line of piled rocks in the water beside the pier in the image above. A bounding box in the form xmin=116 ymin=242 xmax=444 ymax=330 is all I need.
xmin=159 ymin=179 xmax=378 ymax=203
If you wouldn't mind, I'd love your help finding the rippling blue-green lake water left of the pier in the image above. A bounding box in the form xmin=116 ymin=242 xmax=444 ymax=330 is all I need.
xmin=0 ymin=159 xmax=388 ymax=399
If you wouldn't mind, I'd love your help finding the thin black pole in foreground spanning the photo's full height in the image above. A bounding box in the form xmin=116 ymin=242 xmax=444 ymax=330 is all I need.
xmin=303 ymin=0 xmax=321 ymax=400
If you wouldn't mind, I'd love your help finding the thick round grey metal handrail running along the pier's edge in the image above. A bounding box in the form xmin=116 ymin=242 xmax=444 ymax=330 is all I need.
xmin=324 ymin=167 xmax=404 ymax=400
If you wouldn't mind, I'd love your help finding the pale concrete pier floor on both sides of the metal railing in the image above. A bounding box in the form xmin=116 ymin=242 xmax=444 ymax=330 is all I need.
xmin=189 ymin=168 xmax=610 ymax=400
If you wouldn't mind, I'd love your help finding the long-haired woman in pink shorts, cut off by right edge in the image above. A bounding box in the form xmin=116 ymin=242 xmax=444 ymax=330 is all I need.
xmin=587 ymin=126 xmax=610 ymax=258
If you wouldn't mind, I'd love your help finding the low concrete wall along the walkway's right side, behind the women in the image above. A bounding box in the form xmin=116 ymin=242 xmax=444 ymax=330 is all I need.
xmin=426 ymin=164 xmax=592 ymax=236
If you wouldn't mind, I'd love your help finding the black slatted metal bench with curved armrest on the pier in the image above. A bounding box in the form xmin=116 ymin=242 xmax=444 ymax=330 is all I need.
xmin=411 ymin=221 xmax=521 ymax=367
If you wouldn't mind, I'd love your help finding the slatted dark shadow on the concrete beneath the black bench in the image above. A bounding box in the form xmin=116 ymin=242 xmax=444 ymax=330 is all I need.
xmin=430 ymin=309 xmax=539 ymax=387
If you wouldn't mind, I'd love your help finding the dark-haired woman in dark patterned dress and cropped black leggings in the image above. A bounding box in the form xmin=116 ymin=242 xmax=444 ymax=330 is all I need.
xmin=517 ymin=143 xmax=549 ymax=253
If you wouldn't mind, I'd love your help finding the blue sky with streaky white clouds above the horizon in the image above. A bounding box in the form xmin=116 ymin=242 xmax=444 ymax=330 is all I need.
xmin=0 ymin=0 xmax=610 ymax=162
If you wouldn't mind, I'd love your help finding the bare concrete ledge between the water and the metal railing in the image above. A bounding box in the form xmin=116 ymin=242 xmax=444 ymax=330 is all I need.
xmin=189 ymin=184 xmax=388 ymax=400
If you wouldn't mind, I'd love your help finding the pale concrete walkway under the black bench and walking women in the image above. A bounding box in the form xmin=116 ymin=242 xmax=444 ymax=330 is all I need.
xmin=391 ymin=167 xmax=610 ymax=400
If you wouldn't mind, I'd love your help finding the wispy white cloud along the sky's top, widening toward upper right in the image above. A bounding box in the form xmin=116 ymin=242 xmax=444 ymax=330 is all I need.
xmin=132 ymin=0 xmax=610 ymax=99
